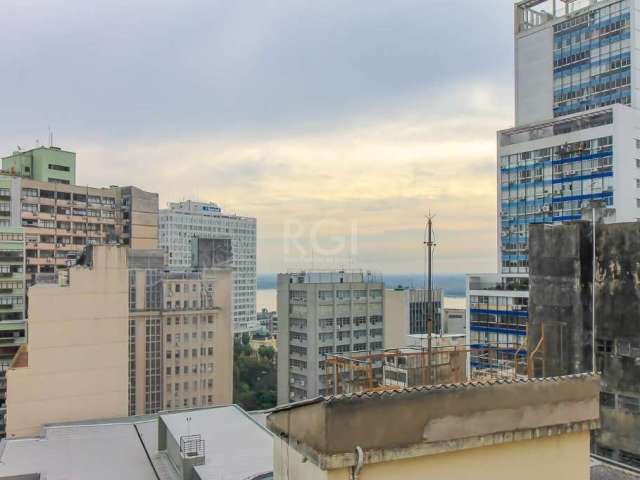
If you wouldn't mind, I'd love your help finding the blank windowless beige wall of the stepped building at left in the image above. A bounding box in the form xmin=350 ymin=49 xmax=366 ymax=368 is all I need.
xmin=7 ymin=246 xmax=129 ymax=437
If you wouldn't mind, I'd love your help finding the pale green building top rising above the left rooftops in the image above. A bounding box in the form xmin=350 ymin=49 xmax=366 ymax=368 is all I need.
xmin=2 ymin=147 xmax=76 ymax=185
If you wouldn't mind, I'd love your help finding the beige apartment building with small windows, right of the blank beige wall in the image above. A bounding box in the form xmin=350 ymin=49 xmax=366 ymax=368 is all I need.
xmin=129 ymin=249 xmax=233 ymax=415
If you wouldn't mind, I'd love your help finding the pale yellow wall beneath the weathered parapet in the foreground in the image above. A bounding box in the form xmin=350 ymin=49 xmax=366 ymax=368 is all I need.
xmin=274 ymin=432 xmax=589 ymax=480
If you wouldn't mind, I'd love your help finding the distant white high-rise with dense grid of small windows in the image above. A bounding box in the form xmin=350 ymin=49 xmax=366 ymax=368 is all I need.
xmin=160 ymin=200 xmax=259 ymax=335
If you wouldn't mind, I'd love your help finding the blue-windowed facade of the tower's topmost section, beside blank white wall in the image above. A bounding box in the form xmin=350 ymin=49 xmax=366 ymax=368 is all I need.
xmin=553 ymin=1 xmax=631 ymax=117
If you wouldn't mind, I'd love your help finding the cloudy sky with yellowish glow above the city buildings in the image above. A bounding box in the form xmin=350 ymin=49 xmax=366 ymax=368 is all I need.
xmin=0 ymin=0 xmax=513 ymax=273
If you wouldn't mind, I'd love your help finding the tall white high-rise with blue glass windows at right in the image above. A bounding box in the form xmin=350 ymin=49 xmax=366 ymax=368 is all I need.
xmin=467 ymin=0 xmax=640 ymax=374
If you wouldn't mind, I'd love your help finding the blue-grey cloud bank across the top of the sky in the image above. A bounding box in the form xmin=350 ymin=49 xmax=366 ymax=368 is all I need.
xmin=0 ymin=0 xmax=512 ymax=148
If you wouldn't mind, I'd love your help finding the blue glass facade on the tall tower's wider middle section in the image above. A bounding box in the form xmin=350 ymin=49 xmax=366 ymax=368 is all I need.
xmin=500 ymin=136 xmax=613 ymax=273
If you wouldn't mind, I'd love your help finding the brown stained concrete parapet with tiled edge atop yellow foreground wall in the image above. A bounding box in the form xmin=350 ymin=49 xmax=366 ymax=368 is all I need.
xmin=268 ymin=375 xmax=600 ymax=468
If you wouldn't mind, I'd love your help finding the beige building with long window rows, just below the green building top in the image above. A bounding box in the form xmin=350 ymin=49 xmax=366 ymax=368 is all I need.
xmin=1 ymin=174 xmax=158 ymax=279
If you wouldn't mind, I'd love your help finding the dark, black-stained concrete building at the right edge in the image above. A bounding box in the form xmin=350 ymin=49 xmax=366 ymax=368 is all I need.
xmin=529 ymin=222 xmax=640 ymax=468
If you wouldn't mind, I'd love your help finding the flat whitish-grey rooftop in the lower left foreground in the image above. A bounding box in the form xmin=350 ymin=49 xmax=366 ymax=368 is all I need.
xmin=0 ymin=405 xmax=273 ymax=480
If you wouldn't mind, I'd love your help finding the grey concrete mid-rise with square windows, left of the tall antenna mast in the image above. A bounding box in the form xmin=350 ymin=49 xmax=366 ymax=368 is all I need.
xmin=277 ymin=271 xmax=384 ymax=404
